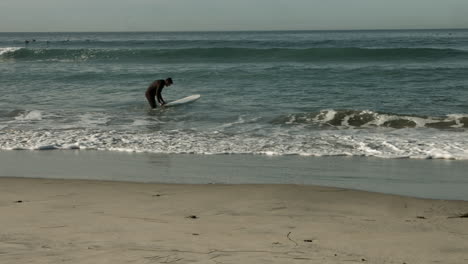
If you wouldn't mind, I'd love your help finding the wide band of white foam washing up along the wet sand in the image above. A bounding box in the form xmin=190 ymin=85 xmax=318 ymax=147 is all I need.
xmin=0 ymin=129 xmax=468 ymax=160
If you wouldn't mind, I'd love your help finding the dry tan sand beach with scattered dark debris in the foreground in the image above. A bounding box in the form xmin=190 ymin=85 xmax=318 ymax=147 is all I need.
xmin=0 ymin=178 xmax=468 ymax=264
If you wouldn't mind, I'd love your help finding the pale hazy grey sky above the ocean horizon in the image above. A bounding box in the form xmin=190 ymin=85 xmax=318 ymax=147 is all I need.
xmin=0 ymin=0 xmax=468 ymax=32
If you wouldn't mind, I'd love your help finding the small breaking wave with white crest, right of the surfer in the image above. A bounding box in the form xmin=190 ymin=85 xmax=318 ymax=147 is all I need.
xmin=272 ymin=110 xmax=468 ymax=129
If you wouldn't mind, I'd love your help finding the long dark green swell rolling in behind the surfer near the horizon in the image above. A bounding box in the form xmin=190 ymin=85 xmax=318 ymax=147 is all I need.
xmin=0 ymin=47 xmax=468 ymax=62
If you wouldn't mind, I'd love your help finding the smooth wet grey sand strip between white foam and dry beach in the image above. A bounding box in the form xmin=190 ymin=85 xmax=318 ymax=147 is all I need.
xmin=0 ymin=150 xmax=468 ymax=201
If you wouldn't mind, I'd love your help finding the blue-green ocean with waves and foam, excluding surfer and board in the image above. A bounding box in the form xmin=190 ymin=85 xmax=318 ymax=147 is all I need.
xmin=0 ymin=30 xmax=468 ymax=160
